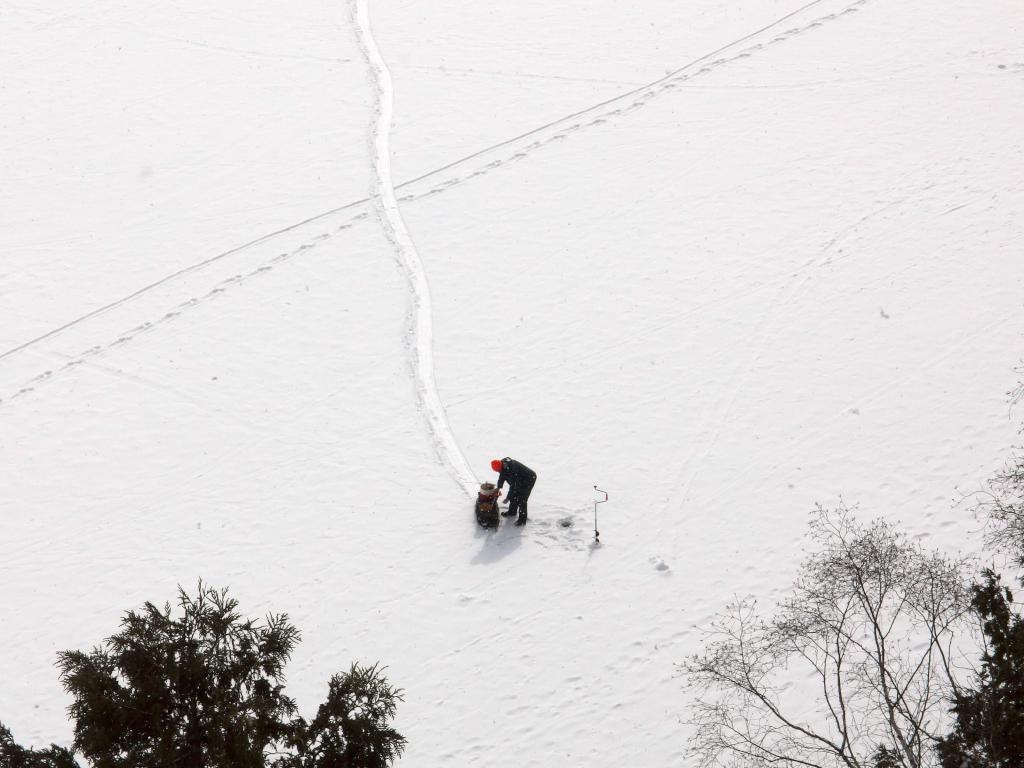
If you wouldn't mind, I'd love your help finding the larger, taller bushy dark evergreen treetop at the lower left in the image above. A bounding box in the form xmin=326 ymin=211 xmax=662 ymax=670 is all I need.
xmin=57 ymin=584 xmax=299 ymax=768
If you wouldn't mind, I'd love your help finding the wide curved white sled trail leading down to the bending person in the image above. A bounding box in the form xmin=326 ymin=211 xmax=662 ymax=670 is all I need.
xmin=349 ymin=0 xmax=479 ymax=497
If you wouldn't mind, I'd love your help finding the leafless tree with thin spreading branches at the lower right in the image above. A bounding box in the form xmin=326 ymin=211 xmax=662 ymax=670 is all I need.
xmin=682 ymin=506 xmax=970 ymax=768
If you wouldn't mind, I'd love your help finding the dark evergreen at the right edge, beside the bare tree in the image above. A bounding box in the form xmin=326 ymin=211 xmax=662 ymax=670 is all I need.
xmin=939 ymin=569 xmax=1024 ymax=768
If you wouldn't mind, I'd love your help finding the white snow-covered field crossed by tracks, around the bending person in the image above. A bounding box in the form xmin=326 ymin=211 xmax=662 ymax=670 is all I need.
xmin=0 ymin=0 xmax=1024 ymax=768
